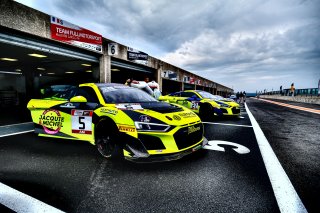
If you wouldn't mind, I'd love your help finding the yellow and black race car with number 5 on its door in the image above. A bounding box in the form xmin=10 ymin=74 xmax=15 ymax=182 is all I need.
xmin=27 ymin=83 xmax=207 ymax=162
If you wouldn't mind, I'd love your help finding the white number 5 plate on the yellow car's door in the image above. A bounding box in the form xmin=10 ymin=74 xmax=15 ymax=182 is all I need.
xmin=71 ymin=109 xmax=93 ymax=135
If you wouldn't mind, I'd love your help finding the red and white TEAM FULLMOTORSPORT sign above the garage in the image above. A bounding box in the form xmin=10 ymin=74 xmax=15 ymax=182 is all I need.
xmin=50 ymin=16 xmax=102 ymax=52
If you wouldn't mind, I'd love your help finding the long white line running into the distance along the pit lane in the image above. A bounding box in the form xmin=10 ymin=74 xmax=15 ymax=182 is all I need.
xmin=245 ymin=104 xmax=307 ymax=213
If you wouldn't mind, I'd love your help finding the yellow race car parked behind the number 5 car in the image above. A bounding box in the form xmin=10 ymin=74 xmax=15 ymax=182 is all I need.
xmin=159 ymin=90 xmax=240 ymax=120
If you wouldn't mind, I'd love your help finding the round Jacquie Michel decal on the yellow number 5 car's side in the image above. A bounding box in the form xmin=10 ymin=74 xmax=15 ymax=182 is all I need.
xmin=39 ymin=109 xmax=64 ymax=135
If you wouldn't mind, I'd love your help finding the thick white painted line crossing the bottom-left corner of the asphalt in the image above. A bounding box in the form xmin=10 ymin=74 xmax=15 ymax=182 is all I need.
xmin=0 ymin=183 xmax=63 ymax=213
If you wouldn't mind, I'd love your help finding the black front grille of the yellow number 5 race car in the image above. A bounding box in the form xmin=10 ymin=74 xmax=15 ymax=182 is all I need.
xmin=173 ymin=123 xmax=203 ymax=149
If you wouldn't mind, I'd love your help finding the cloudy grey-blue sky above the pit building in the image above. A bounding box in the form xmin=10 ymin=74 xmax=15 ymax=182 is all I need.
xmin=18 ymin=0 xmax=320 ymax=92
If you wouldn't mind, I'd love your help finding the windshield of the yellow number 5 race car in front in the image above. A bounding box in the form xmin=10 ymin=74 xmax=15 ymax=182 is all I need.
xmin=99 ymin=86 xmax=157 ymax=103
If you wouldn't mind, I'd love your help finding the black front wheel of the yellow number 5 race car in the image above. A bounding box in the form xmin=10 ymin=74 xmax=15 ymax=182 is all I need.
xmin=95 ymin=120 xmax=123 ymax=160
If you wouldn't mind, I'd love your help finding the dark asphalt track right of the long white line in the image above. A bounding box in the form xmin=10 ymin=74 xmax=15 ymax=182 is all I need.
xmin=247 ymin=99 xmax=320 ymax=212
